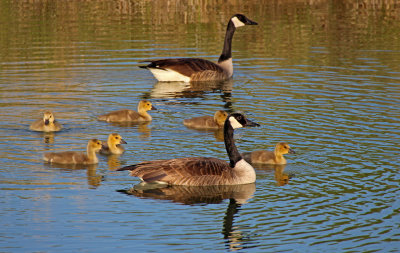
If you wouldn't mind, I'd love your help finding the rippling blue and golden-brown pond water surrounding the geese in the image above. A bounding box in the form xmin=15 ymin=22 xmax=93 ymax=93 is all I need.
xmin=0 ymin=0 xmax=400 ymax=252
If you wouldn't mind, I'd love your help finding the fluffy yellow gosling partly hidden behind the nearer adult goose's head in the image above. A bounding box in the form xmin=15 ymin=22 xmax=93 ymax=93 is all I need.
xmin=183 ymin=110 xmax=228 ymax=129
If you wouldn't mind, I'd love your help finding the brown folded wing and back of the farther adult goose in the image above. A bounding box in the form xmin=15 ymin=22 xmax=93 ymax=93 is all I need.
xmin=146 ymin=58 xmax=224 ymax=77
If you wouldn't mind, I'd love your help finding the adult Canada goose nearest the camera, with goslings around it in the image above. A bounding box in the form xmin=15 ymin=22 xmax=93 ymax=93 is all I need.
xmin=118 ymin=113 xmax=259 ymax=186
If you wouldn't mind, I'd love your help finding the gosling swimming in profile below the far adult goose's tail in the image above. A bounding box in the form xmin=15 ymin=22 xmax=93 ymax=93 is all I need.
xmin=97 ymin=100 xmax=156 ymax=122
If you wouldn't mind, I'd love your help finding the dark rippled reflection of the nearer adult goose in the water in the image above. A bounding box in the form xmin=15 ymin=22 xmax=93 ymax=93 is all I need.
xmin=118 ymin=182 xmax=256 ymax=251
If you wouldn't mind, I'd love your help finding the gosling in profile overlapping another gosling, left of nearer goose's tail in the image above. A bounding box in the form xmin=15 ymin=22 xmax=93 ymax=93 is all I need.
xmin=43 ymin=139 xmax=101 ymax=164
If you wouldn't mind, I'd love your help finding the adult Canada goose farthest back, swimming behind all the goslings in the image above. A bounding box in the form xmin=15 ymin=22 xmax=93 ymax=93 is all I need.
xmin=139 ymin=14 xmax=257 ymax=82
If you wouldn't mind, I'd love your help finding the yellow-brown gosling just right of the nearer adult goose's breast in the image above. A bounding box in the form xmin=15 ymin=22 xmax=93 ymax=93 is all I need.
xmin=242 ymin=142 xmax=296 ymax=164
